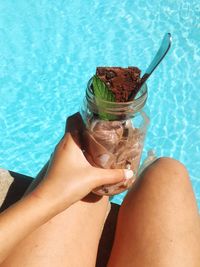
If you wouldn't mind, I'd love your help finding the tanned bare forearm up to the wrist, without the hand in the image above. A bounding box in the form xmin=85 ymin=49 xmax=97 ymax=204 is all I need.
xmin=0 ymin=192 xmax=58 ymax=263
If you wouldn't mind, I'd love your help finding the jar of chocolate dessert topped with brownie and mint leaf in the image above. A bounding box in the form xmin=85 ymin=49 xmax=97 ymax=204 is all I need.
xmin=81 ymin=67 xmax=149 ymax=196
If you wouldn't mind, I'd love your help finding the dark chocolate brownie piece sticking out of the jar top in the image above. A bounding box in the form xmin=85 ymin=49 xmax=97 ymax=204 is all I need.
xmin=96 ymin=67 xmax=141 ymax=102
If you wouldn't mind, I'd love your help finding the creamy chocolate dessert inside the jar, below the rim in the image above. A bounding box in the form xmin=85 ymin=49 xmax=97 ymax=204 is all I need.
xmin=84 ymin=120 xmax=144 ymax=196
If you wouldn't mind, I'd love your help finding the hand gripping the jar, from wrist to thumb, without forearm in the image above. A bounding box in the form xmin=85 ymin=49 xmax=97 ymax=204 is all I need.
xmin=32 ymin=133 xmax=133 ymax=212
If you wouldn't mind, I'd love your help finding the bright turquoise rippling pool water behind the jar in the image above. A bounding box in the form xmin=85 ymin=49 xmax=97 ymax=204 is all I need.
xmin=0 ymin=0 xmax=200 ymax=207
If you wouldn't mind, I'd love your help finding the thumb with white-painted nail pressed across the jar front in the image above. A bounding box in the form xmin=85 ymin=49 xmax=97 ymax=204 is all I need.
xmin=92 ymin=168 xmax=135 ymax=186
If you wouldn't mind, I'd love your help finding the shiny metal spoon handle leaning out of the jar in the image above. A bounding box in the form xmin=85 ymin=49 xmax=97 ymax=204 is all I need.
xmin=129 ymin=33 xmax=172 ymax=99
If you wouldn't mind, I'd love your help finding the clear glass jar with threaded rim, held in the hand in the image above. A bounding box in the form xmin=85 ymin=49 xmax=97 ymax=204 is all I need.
xmin=81 ymin=79 xmax=149 ymax=196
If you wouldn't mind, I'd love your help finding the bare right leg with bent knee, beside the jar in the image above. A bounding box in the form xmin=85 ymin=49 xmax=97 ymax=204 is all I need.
xmin=108 ymin=158 xmax=200 ymax=267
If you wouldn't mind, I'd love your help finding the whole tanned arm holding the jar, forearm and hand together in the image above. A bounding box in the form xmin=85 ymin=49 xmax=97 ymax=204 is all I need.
xmin=0 ymin=113 xmax=133 ymax=264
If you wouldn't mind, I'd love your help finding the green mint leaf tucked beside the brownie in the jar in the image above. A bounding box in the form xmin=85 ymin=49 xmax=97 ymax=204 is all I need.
xmin=92 ymin=75 xmax=115 ymax=120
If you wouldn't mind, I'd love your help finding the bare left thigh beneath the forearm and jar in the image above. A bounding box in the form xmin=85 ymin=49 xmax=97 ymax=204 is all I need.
xmin=1 ymin=197 xmax=109 ymax=267
